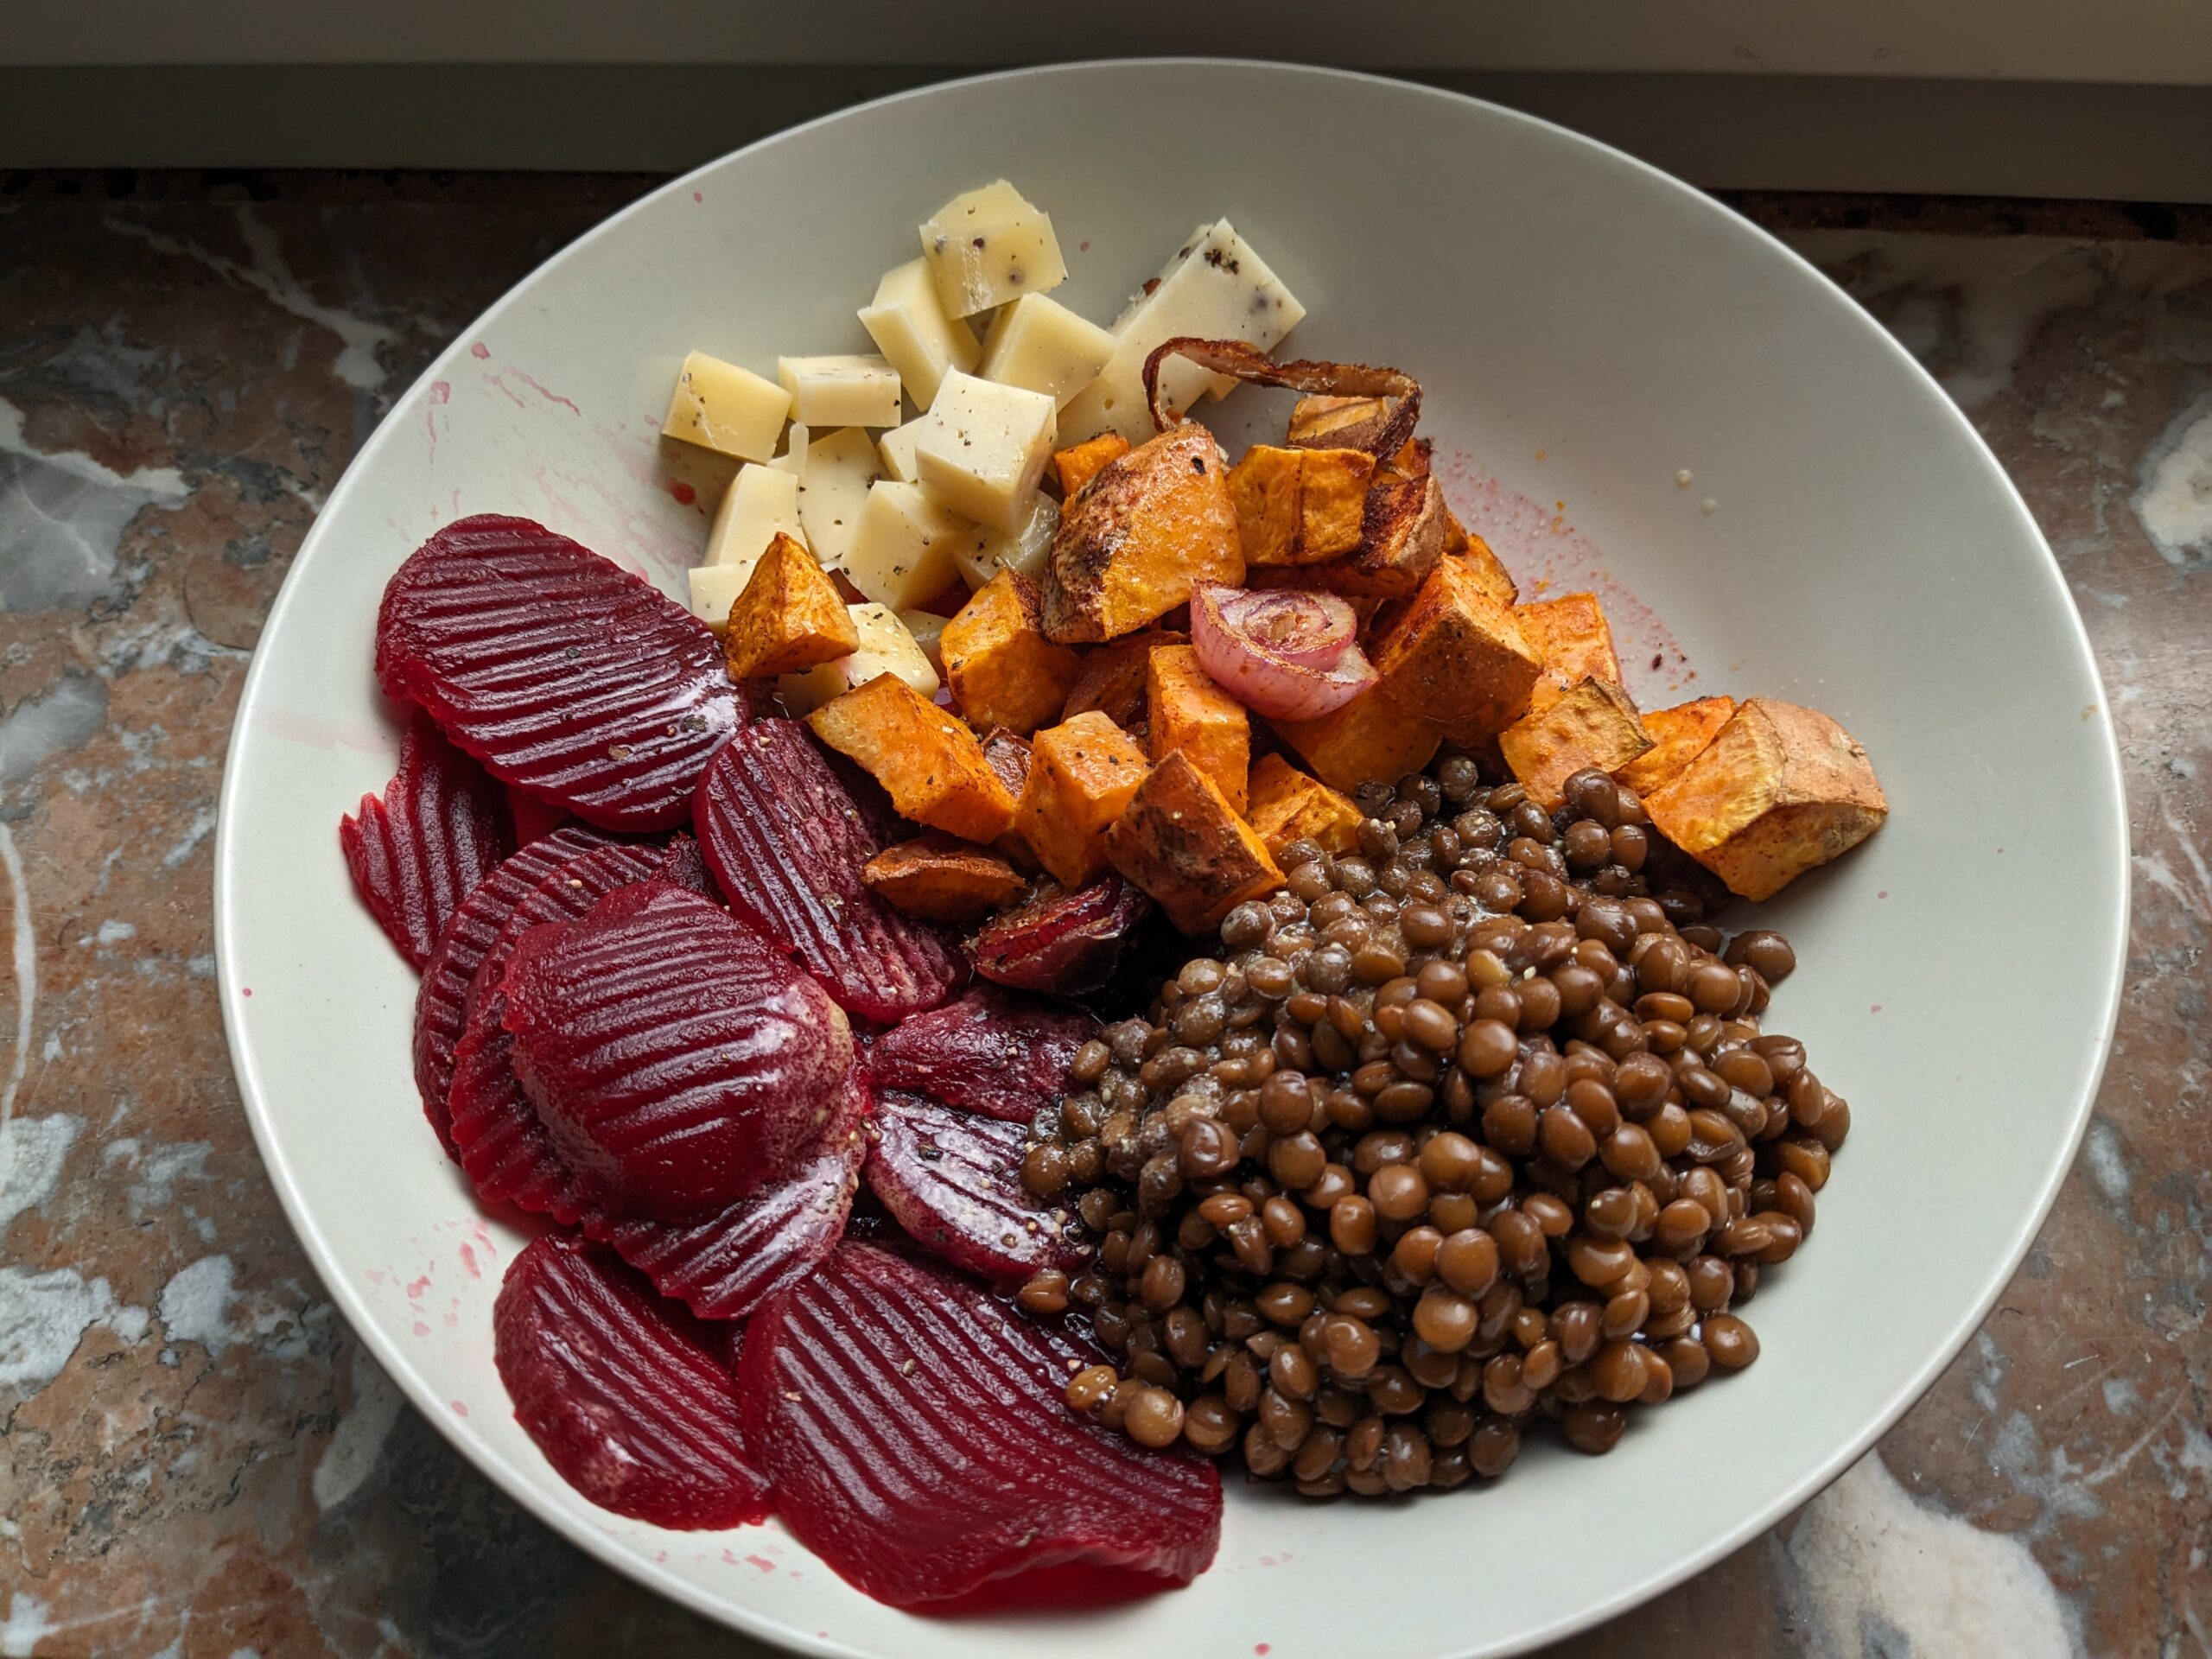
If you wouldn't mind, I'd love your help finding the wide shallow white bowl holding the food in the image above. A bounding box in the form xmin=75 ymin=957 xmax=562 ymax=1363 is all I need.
xmin=217 ymin=62 xmax=2128 ymax=1659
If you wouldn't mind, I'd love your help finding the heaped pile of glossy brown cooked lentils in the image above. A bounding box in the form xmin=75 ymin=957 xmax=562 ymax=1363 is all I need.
xmin=1020 ymin=757 xmax=1852 ymax=1497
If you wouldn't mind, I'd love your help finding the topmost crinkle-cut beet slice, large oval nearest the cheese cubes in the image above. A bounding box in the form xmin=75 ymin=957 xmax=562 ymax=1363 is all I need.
xmin=376 ymin=513 xmax=741 ymax=830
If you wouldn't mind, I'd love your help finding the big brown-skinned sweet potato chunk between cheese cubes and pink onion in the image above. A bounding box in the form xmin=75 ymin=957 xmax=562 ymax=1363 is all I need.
xmin=1044 ymin=420 xmax=1243 ymax=646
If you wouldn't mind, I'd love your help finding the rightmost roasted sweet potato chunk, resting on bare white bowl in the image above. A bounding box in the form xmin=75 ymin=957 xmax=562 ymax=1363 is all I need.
xmin=1643 ymin=696 xmax=1889 ymax=898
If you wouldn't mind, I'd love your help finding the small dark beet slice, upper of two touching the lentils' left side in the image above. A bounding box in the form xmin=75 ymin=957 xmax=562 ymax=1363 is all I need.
xmin=869 ymin=984 xmax=1099 ymax=1123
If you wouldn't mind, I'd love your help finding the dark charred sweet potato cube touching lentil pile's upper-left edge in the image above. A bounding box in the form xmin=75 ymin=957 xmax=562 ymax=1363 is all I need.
xmin=1106 ymin=752 xmax=1283 ymax=933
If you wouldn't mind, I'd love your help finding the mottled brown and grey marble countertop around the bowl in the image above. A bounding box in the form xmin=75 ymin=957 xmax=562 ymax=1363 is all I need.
xmin=0 ymin=175 xmax=2212 ymax=1659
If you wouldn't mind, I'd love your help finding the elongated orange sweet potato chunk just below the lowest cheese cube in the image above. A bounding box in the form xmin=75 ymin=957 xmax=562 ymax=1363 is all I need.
xmin=807 ymin=675 xmax=1013 ymax=841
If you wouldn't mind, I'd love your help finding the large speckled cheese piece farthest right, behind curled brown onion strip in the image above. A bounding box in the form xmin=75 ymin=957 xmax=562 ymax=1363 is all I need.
xmin=1059 ymin=219 xmax=1305 ymax=442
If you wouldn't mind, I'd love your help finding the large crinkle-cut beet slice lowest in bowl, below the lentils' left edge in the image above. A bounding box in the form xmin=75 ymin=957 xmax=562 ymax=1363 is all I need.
xmin=739 ymin=1241 xmax=1221 ymax=1606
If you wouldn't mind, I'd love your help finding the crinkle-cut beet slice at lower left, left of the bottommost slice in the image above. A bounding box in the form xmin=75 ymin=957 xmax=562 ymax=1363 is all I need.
xmin=493 ymin=1234 xmax=772 ymax=1529
